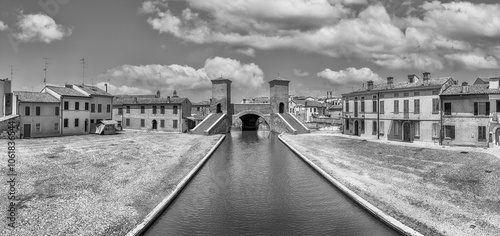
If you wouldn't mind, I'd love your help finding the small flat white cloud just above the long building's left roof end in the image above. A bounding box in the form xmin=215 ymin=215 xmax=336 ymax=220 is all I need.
xmin=317 ymin=67 xmax=382 ymax=85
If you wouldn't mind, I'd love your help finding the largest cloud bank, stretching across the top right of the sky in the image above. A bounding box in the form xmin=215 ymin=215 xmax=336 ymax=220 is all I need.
xmin=142 ymin=0 xmax=500 ymax=71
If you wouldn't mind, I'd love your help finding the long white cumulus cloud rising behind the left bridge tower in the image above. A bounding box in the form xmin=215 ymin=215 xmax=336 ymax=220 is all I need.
xmin=99 ymin=57 xmax=264 ymax=93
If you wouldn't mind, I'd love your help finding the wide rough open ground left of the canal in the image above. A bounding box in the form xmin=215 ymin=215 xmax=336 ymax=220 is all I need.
xmin=0 ymin=131 xmax=220 ymax=235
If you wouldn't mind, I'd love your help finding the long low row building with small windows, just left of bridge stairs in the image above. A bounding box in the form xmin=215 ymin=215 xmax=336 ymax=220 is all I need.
xmin=113 ymin=92 xmax=194 ymax=133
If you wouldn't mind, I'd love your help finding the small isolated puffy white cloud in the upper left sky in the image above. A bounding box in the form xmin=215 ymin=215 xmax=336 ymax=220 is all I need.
xmin=13 ymin=13 xmax=73 ymax=43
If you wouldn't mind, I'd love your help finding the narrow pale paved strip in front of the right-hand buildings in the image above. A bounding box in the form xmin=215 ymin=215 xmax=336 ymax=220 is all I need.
xmin=310 ymin=131 xmax=500 ymax=159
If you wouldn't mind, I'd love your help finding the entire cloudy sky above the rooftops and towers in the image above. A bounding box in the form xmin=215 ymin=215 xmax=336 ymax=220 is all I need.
xmin=0 ymin=0 xmax=500 ymax=102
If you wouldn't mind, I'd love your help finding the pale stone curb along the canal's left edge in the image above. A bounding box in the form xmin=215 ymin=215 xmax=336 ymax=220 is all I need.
xmin=126 ymin=135 xmax=226 ymax=236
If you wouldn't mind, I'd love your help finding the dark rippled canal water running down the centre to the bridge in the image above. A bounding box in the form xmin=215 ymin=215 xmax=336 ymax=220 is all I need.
xmin=145 ymin=131 xmax=399 ymax=236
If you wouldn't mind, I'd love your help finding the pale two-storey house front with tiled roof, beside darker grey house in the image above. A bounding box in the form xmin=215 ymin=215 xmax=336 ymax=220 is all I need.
xmin=42 ymin=86 xmax=90 ymax=135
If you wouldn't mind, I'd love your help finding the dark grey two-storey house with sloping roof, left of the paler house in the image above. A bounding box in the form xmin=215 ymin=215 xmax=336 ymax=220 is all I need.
xmin=13 ymin=91 xmax=61 ymax=138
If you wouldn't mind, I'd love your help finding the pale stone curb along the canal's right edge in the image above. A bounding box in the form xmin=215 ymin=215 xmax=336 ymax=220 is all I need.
xmin=278 ymin=134 xmax=423 ymax=236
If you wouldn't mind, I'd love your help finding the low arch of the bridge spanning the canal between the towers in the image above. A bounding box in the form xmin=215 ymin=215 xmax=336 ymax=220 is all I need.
xmin=233 ymin=110 xmax=271 ymax=130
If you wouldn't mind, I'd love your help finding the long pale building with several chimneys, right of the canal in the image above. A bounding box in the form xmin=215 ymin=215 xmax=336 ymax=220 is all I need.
xmin=342 ymin=72 xmax=455 ymax=142
